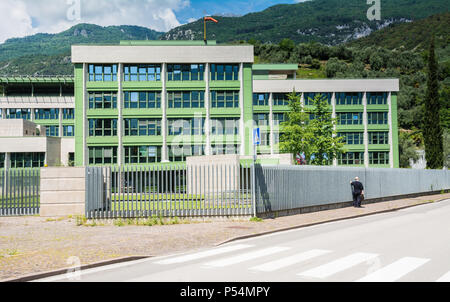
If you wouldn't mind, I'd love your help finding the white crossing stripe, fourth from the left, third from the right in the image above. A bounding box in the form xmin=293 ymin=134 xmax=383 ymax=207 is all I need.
xmin=297 ymin=253 xmax=378 ymax=279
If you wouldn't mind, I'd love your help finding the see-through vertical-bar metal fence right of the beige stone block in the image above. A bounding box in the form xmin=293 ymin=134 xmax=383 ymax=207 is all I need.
xmin=86 ymin=164 xmax=254 ymax=219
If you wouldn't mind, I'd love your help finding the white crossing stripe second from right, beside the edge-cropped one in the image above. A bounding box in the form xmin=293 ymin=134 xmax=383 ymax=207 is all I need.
xmin=358 ymin=257 xmax=430 ymax=282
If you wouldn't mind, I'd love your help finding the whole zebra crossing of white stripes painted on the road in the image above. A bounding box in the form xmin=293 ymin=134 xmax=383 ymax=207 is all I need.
xmin=153 ymin=244 xmax=450 ymax=282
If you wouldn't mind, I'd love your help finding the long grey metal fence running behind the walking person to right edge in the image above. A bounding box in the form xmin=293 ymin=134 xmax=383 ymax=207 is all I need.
xmin=255 ymin=165 xmax=450 ymax=213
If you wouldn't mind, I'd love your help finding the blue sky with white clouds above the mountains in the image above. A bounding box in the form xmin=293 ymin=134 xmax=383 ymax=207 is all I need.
xmin=0 ymin=0 xmax=306 ymax=43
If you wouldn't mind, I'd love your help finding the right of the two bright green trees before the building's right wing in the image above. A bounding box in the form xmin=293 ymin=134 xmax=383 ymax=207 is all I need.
xmin=310 ymin=94 xmax=344 ymax=166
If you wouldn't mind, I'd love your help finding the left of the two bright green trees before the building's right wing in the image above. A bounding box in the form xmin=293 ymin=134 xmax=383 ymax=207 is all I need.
xmin=280 ymin=90 xmax=314 ymax=164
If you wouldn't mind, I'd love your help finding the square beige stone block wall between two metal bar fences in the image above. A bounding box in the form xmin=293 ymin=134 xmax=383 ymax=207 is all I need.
xmin=40 ymin=168 xmax=86 ymax=217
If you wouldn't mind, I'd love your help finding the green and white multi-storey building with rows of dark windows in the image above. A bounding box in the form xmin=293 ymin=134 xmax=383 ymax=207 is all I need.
xmin=67 ymin=41 xmax=399 ymax=167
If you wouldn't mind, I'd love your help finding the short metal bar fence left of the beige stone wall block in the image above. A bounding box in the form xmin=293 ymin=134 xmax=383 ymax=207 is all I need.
xmin=0 ymin=169 xmax=40 ymax=216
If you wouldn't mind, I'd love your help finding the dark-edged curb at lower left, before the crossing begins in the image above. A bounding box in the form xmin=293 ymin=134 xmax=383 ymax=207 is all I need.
xmin=0 ymin=256 xmax=153 ymax=282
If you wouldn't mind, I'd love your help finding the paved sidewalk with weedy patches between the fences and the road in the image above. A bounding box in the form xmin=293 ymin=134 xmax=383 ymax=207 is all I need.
xmin=0 ymin=193 xmax=450 ymax=280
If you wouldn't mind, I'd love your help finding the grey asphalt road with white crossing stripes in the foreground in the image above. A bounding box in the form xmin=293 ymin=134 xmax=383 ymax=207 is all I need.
xmin=39 ymin=200 xmax=450 ymax=282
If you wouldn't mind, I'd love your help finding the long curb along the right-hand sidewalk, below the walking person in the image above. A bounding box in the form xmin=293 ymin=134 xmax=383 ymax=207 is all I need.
xmin=215 ymin=198 xmax=449 ymax=246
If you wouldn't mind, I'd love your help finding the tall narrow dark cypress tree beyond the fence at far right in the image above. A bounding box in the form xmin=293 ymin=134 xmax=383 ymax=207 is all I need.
xmin=423 ymin=36 xmax=444 ymax=169
